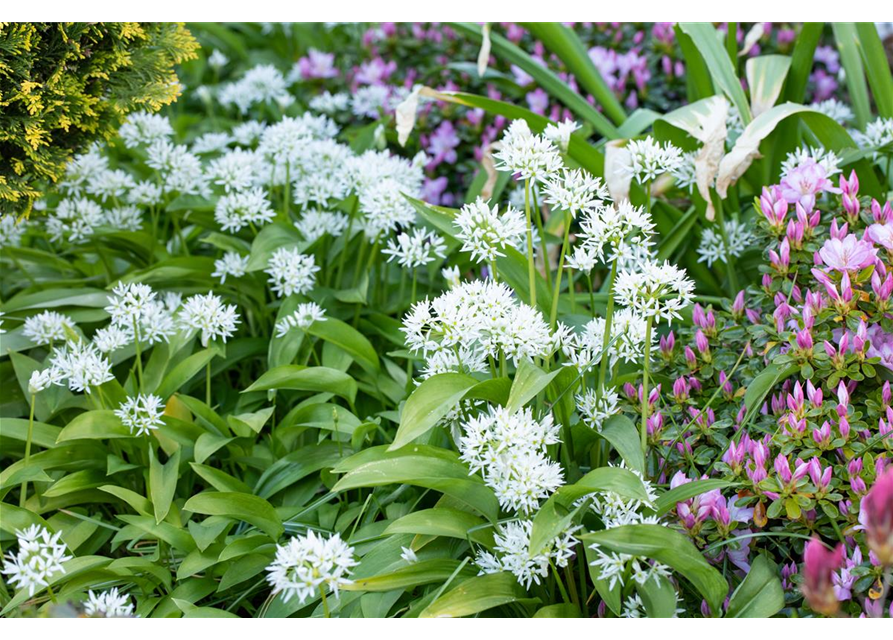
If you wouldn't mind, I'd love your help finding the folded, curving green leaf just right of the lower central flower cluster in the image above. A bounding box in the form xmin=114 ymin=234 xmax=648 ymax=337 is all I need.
xmin=530 ymin=467 xmax=648 ymax=554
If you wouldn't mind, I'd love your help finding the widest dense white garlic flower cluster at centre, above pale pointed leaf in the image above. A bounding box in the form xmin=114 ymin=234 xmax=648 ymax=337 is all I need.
xmin=401 ymin=280 xmax=554 ymax=371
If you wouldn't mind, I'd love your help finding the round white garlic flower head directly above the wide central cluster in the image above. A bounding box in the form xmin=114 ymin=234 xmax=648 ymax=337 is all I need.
xmin=453 ymin=197 xmax=527 ymax=262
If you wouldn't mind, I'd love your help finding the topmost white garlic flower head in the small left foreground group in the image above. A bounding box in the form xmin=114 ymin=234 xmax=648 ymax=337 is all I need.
xmin=103 ymin=282 xmax=176 ymax=350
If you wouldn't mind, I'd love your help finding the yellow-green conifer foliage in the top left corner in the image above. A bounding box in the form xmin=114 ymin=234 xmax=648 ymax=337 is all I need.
xmin=0 ymin=22 xmax=199 ymax=213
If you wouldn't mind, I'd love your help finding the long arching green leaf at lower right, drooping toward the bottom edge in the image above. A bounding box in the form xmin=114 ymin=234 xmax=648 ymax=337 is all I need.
xmin=580 ymin=524 xmax=729 ymax=615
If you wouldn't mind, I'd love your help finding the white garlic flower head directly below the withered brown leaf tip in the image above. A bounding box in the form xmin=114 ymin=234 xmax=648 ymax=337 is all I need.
xmin=578 ymin=200 xmax=654 ymax=262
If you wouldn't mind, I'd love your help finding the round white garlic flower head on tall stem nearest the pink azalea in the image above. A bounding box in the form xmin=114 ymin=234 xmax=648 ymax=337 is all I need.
xmin=614 ymin=261 xmax=695 ymax=322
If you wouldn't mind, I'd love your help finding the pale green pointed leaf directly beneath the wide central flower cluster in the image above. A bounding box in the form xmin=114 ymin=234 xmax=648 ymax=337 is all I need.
xmin=390 ymin=373 xmax=478 ymax=451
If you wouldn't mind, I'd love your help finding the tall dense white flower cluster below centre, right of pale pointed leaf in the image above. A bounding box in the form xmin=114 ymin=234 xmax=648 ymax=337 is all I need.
xmin=458 ymin=406 xmax=564 ymax=514
